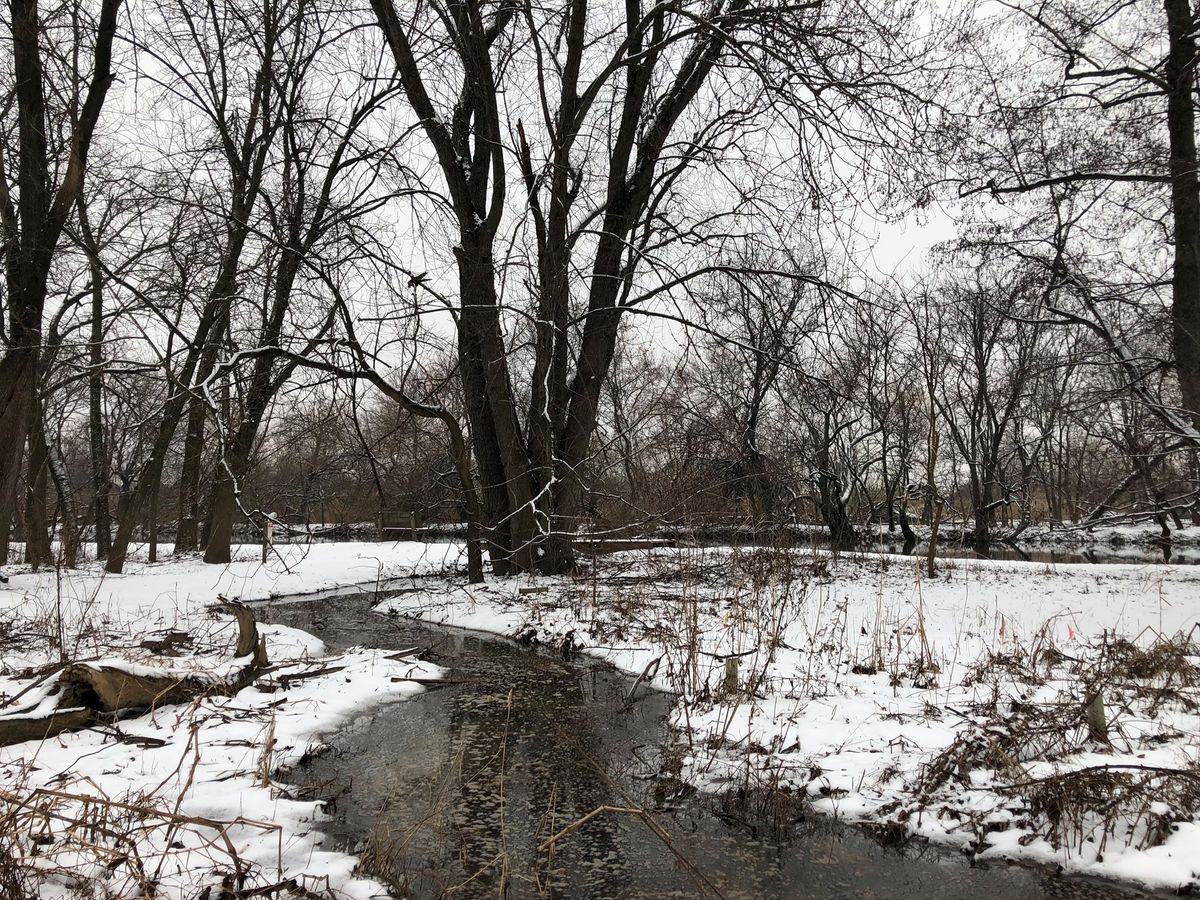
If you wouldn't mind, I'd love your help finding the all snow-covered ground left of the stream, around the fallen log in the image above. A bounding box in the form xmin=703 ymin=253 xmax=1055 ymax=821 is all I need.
xmin=0 ymin=544 xmax=458 ymax=898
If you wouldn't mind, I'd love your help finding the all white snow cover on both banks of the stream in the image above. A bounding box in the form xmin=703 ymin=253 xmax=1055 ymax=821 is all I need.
xmin=0 ymin=542 xmax=1200 ymax=898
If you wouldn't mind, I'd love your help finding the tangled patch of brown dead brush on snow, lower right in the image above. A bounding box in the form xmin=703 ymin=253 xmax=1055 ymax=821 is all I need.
xmin=902 ymin=631 xmax=1200 ymax=860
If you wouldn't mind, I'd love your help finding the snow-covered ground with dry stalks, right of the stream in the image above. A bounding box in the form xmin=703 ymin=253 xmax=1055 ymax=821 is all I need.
xmin=383 ymin=550 xmax=1200 ymax=889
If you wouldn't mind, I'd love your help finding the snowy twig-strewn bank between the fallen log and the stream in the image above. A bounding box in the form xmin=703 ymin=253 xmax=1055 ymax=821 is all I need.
xmin=0 ymin=650 xmax=439 ymax=900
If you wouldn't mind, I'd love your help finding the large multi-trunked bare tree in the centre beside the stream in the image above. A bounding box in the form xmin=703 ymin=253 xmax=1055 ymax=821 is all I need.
xmin=372 ymin=0 xmax=931 ymax=571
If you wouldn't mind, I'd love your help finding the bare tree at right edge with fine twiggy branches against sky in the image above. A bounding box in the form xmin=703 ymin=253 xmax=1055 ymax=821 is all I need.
xmin=955 ymin=0 xmax=1200 ymax=445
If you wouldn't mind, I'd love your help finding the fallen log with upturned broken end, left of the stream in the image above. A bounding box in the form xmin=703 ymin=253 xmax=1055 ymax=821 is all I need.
xmin=0 ymin=601 xmax=266 ymax=746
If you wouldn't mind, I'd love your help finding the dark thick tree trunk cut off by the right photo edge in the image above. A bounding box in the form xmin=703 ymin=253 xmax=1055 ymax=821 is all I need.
xmin=1164 ymin=0 xmax=1200 ymax=427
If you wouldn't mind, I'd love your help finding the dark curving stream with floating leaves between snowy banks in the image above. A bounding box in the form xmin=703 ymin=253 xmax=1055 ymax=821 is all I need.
xmin=258 ymin=594 xmax=1144 ymax=900
